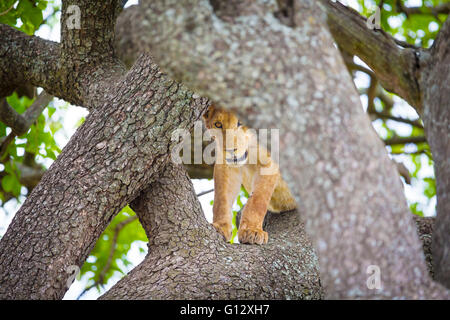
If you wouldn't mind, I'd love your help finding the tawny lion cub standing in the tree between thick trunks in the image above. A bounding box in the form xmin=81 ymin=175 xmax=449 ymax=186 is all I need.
xmin=203 ymin=106 xmax=297 ymax=244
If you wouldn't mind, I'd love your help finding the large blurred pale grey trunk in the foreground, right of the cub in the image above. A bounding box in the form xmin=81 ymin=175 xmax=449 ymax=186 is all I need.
xmin=114 ymin=0 xmax=448 ymax=298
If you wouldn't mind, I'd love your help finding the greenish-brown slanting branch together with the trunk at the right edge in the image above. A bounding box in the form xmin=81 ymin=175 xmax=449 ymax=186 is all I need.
xmin=322 ymin=0 xmax=450 ymax=288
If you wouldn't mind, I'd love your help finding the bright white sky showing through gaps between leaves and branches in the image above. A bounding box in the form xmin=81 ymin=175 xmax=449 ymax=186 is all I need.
xmin=0 ymin=0 xmax=436 ymax=299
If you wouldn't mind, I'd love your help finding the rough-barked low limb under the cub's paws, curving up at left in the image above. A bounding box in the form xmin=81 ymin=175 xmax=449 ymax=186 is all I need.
xmin=101 ymin=164 xmax=322 ymax=299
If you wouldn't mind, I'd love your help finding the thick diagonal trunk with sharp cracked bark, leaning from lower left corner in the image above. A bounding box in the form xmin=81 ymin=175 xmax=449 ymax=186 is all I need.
xmin=0 ymin=55 xmax=208 ymax=299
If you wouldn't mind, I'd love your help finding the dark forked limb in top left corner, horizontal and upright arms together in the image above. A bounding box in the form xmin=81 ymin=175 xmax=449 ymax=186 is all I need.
xmin=0 ymin=0 xmax=125 ymax=108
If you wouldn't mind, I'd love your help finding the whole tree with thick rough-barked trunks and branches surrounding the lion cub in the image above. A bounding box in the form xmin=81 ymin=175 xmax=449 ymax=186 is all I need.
xmin=0 ymin=0 xmax=450 ymax=299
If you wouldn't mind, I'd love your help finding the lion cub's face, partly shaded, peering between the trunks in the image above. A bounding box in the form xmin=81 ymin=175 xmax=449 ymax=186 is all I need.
xmin=203 ymin=106 xmax=251 ymax=166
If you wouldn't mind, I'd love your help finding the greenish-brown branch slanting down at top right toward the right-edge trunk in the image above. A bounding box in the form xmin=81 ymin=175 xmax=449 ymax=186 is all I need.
xmin=321 ymin=0 xmax=423 ymax=114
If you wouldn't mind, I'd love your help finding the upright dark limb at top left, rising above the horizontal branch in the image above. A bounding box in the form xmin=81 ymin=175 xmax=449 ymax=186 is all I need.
xmin=60 ymin=0 xmax=125 ymax=108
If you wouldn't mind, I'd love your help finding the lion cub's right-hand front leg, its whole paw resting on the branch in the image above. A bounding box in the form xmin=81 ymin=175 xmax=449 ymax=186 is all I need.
xmin=238 ymin=174 xmax=278 ymax=244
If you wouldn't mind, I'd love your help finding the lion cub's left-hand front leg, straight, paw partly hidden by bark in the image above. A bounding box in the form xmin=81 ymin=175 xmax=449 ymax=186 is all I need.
xmin=213 ymin=164 xmax=242 ymax=241
